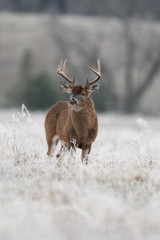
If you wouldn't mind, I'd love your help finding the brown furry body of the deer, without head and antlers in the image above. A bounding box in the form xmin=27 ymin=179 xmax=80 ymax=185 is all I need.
xmin=45 ymin=96 xmax=98 ymax=161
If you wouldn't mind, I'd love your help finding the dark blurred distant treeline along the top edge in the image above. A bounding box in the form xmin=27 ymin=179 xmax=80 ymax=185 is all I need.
xmin=0 ymin=0 xmax=160 ymax=19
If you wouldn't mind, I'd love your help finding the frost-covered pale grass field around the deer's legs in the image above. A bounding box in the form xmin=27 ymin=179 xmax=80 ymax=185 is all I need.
xmin=0 ymin=107 xmax=160 ymax=240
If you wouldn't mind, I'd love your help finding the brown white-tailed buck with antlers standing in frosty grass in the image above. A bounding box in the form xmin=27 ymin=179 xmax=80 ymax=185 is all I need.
xmin=45 ymin=59 xmax=101 ymax=164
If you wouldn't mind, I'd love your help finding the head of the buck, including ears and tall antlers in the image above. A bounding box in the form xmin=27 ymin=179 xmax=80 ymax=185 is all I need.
xmin=57 ymin=59 xmax=101 ymax=107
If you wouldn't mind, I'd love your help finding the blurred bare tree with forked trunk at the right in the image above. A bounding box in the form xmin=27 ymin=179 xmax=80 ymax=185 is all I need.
xmin=122 ymin=0 xmax=160 ymax=113
